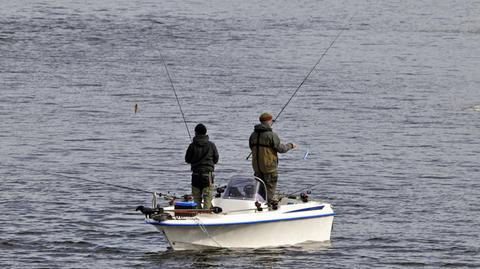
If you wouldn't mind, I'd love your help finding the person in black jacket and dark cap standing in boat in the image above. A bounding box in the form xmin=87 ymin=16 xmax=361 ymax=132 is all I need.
xmin=185 ymin=123 xmax=218 ymax=209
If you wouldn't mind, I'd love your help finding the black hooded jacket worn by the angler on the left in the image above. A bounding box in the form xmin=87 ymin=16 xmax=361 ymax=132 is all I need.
xmin=185 ymin=134 xmax=218 ymax=173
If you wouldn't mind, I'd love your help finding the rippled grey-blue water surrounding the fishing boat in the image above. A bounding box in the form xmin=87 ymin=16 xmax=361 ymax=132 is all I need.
xmin=0 ymin=0 xmax=480 ymax=268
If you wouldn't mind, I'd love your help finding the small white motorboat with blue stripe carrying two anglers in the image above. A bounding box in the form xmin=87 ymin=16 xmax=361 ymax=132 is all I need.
xmin=142 ymin=178 xmax=335 ymax=250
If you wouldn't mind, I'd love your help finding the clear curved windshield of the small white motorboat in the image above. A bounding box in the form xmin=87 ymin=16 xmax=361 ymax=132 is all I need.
xmin=223 ymin=178 xmax=265 ymax=202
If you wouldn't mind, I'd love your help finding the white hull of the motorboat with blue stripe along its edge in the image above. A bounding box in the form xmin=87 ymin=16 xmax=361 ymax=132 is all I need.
xmin=151 ymin=207 xmax=334 ymax=250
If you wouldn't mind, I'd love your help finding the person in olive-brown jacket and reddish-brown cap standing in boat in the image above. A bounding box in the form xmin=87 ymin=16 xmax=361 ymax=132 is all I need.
xmin=249 ymin=113 xmax=297 ymax=204
